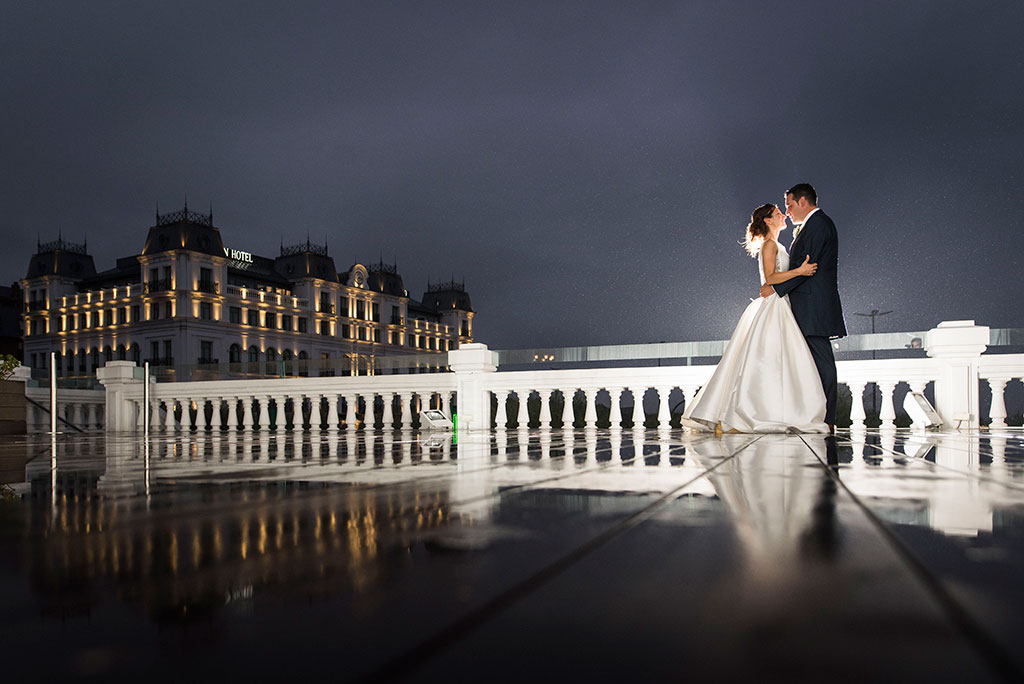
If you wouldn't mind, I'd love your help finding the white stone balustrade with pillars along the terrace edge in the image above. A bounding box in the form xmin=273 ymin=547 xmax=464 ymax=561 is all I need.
xmin=77 ymin=322 xmax=1024 ymax=433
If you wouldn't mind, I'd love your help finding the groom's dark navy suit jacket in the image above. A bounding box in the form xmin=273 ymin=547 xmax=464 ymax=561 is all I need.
xmin=772 ymin=209 xmax=846 ymax=337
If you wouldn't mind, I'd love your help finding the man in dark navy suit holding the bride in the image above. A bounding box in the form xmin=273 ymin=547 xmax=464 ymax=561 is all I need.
xmin=761 ymin=183 xmax=846 ymax=432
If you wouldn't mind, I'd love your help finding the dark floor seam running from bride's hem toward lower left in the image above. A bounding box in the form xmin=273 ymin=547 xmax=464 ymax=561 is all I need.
xmin=355 ymin=436 xmax=762 ymax=683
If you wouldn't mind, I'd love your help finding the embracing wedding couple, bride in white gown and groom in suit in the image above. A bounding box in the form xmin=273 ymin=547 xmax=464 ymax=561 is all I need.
xmin=682 ymin=183 xmax=846 ymax=432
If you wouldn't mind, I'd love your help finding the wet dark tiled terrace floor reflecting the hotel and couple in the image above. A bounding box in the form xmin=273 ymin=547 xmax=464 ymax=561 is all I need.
xmin=0 ymin=429 xmax=1024 ymax=682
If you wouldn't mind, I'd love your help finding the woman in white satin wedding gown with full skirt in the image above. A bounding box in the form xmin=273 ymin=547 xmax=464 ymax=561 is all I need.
xmin=682 ymin=204 xmax=828 ymax=432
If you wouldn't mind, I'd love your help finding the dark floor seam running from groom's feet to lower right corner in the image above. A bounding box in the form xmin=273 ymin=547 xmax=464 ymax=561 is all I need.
xmin=800 ymin=435 xmax=1024 ymax=682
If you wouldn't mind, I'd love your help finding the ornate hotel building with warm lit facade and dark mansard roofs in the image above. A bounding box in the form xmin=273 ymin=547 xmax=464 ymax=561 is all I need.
xmin=20 ymin=206 xmax=473 ymax=376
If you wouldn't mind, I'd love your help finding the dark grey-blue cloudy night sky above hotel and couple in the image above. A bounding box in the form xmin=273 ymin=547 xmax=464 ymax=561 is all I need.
xmin=0 ymin=0 xmax=1024 ymax=348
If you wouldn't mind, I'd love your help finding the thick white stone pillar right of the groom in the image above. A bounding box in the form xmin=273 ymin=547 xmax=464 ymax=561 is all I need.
xmin=925 ymin=320 xmax=988 ymax=430
